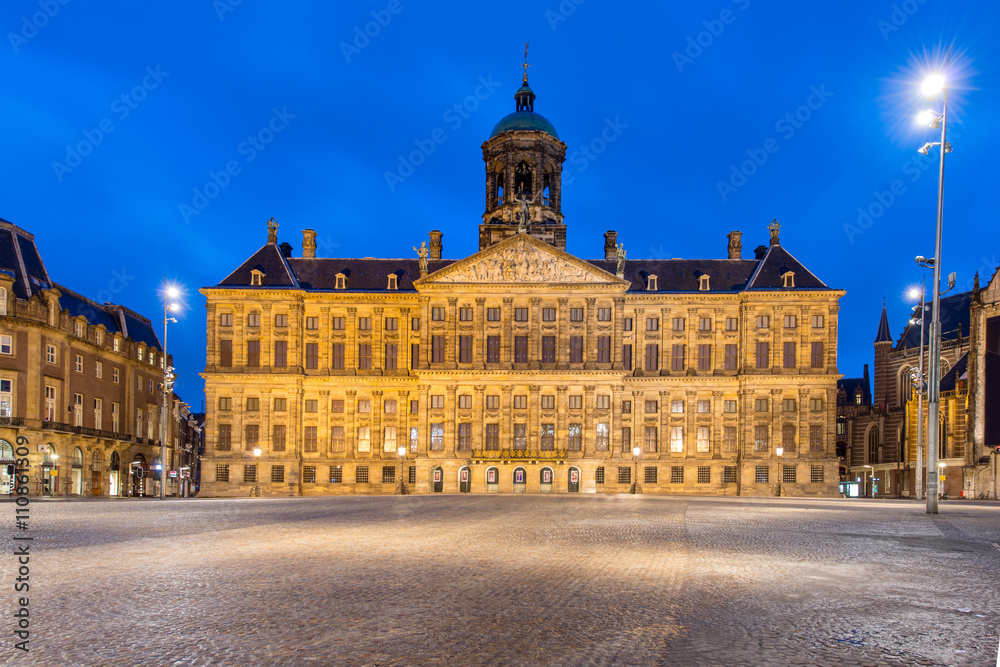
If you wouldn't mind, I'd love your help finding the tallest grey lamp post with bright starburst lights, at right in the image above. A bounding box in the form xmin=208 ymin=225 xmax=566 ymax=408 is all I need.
xmin=919 ymin=57 xmax=951 ymax=514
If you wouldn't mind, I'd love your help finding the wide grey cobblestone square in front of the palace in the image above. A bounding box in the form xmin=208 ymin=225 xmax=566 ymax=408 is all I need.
xmin=2 ymin=495 xmax=1000 ymax=666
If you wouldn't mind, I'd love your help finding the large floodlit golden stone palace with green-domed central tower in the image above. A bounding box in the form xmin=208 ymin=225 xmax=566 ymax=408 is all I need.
xmin=202 ymin=69 xmax=844 ymax=496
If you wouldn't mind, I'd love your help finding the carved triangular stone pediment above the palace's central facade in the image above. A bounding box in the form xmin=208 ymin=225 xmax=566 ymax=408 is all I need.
xmin=416 ymin=234 xmax=625 ymax=285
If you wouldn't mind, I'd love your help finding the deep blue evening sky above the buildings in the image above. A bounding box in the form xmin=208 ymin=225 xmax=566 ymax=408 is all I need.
xmin=0 ymin=0 xmax=1000 ymax=410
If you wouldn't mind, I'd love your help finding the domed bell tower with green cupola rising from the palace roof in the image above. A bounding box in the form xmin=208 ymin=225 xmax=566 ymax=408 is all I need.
xmin=479 ymin=47 xmax=566 ymax=250
